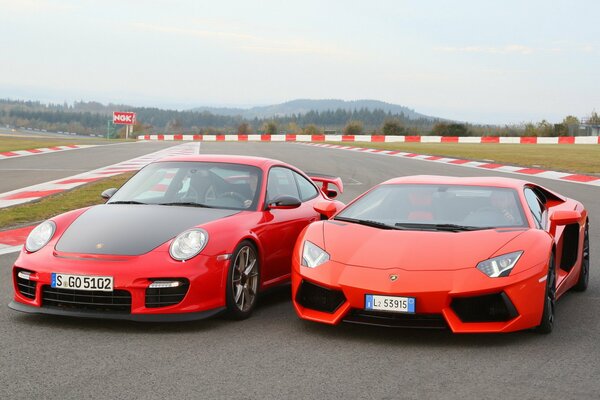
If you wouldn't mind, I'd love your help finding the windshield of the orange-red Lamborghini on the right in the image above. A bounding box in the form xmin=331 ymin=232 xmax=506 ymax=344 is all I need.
xmin=335 ymin=184 xmax=527 ymax=231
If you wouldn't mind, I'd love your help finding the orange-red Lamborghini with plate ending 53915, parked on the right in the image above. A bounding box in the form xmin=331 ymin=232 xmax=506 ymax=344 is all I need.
xmin=292 ymin=176 xmax=590 ymax=333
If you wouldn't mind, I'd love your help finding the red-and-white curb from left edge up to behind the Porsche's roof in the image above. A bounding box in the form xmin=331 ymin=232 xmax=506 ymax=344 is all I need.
xmin=0 ymin=143 xmax=200 ymax=209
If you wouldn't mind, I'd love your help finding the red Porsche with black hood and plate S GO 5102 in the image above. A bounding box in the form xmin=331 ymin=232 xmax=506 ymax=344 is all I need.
xmin=9 ymin=155 xmax=343 ymax=321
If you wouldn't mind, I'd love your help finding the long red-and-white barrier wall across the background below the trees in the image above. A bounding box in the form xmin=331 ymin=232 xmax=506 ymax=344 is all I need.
xmin=138 ymin=134 xmax=600 ymax=144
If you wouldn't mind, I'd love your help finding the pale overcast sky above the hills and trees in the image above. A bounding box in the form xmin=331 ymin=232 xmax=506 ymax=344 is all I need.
xmin=0 ymin=0 xmax=600 ymax=123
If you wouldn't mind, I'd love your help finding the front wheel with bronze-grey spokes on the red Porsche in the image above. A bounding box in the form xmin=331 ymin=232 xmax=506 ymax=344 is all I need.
xmin=226 ymin=240 xmax=260 ymax=320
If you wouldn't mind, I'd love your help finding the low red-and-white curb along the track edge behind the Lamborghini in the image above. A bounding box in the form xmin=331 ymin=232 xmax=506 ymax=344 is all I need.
xmin=301 ymin=143 xmax=600 ymax=187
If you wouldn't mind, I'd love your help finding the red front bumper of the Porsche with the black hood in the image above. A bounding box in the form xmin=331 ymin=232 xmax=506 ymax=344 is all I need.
xmin=9 ymin=249 xmax=229 ymax=321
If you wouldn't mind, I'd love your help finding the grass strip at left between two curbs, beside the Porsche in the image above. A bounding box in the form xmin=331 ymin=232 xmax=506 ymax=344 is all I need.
xmin=0 ymin=172 xmax=133 ymax=230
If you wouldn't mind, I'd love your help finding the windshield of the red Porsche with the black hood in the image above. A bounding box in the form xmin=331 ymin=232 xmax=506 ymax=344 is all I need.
xmin=107 ymin=162 xmax=262 ymax=210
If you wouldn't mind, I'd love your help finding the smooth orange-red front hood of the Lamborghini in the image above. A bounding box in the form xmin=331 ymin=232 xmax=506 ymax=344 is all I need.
xmin=323 ymin=221 xmax=526 ymax=271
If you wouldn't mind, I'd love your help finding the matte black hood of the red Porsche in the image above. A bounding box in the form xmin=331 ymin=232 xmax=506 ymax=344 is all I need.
xmin=56 ymin=204 xmax=239 ymax=256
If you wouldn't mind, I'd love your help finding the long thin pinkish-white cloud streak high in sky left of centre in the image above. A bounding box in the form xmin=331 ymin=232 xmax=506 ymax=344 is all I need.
xmin=131 ymin=22 xmax=352 ymax=56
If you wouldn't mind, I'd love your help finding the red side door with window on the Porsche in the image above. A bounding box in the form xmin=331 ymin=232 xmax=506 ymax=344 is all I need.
xmin=259 ymin=166 xmax=320 ymax=286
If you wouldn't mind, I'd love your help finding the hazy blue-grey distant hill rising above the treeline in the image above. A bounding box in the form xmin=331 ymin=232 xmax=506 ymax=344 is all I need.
xmin=191 ymin=99 xmax=435 ymax=120
